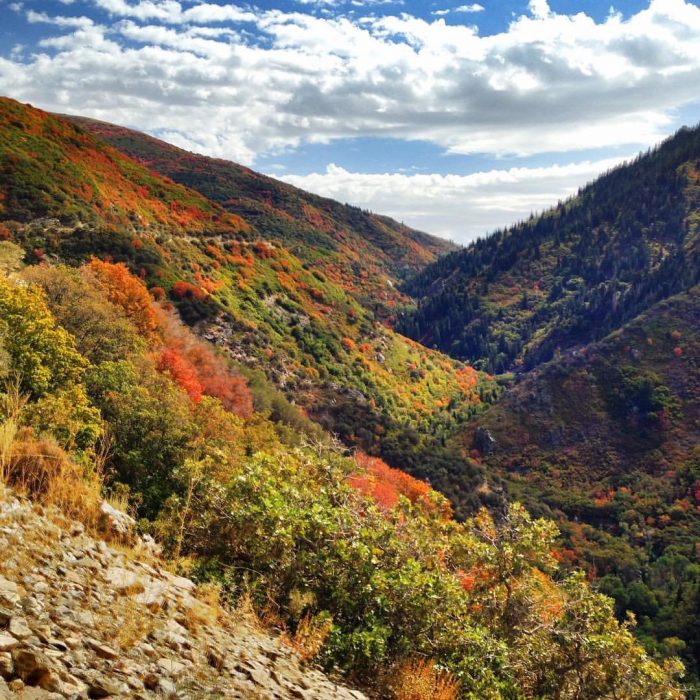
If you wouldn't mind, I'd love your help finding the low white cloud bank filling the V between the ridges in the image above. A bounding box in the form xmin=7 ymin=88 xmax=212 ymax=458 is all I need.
xmin=275 ymin=158 xmax=621 ymax=243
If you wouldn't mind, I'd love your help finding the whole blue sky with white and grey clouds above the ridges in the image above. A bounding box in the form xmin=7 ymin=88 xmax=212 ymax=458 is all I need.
xmin=0 ymin=0 xmax=700 ymax=243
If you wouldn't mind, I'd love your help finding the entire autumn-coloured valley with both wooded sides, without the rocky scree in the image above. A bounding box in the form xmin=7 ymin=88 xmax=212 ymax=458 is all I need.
xmin=0 ymin=98 xmax=700 ymax=700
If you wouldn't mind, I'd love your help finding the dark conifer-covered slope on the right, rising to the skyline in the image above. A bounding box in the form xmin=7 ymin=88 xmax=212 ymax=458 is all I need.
xmin=397 ymin=128 xmax=700 ymax=372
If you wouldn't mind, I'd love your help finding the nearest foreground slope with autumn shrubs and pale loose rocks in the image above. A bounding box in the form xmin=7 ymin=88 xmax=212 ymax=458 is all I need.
xmin=0 ymin=253 xmax=682 ymax=700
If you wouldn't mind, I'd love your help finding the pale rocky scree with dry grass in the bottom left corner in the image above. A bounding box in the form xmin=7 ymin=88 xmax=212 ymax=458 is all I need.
xmin=0 ymin=493 xmax=365 ymax=700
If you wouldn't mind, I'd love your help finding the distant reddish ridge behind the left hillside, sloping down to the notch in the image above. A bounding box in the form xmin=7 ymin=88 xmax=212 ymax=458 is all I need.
xmin=65 ymin=116 xmax=456 ymax=314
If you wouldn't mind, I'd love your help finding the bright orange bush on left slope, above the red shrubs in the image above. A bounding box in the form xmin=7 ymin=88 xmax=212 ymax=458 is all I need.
xmin=88 ymin=258 xmax=157 ymax=336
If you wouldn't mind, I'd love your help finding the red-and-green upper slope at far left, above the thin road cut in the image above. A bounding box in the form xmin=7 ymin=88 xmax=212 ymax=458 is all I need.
xmin=0 ymin=97 xmax=248 ymax=235
